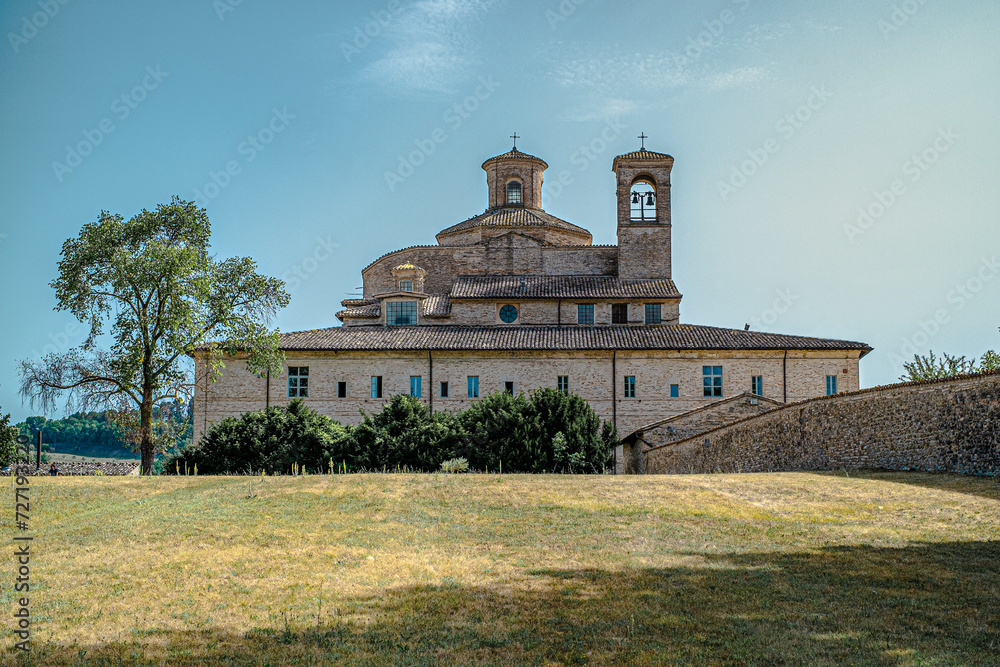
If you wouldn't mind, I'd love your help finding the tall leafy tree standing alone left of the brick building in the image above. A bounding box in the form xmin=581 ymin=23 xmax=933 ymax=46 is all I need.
xmin=19 ymin=197 xmax=289 ymax=474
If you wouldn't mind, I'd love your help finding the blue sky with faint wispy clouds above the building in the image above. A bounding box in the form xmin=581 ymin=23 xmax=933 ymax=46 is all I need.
xmin=0 ymin=0 xmax=1000 ymax=421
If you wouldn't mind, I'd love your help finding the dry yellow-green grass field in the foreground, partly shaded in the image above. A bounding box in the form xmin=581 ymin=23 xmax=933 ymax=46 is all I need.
xmin=0 ymin=473 xmax=1000 ymax=665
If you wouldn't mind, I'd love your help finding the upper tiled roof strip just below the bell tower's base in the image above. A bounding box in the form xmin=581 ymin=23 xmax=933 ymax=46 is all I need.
xmin=451 ymin=276 xmax=681 ymax=299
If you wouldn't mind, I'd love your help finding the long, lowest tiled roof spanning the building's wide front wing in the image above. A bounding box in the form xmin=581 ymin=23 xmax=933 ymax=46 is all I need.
xmin=272 ymin=324 xmax=871 ymax=356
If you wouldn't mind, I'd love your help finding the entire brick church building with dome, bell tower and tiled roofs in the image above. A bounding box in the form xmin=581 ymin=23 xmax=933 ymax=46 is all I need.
xmin=195 ymin=148 xmax=871 ymax=462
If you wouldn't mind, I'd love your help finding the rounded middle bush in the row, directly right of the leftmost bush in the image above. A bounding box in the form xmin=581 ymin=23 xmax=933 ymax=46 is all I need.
xmin=353 ymin=394 xmax=461 ymax=472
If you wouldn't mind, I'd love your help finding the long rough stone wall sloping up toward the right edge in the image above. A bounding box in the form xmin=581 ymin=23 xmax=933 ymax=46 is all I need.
xmin=637 ymin=372 xmax=1000 ymax=475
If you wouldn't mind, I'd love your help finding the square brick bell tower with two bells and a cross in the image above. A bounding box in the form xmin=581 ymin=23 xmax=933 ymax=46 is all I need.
xmin=612 ymin=134 xmax=674 ymax=280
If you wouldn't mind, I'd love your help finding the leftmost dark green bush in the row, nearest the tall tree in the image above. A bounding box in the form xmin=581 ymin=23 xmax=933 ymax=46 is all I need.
xmin=162 ymin=399 xmax=357 ymax=475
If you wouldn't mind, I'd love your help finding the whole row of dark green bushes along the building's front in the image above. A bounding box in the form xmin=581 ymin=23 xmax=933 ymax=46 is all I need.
xmin=161 ymin=389 xmax=618 ymax=474
